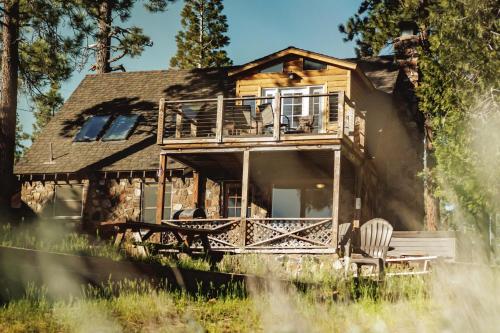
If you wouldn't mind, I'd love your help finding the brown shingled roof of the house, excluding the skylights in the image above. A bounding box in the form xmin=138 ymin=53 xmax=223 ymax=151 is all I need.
xmin=14 ymin=53 xmax=399 ymax=175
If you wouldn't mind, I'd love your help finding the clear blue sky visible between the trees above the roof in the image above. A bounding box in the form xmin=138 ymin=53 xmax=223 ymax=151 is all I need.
xmin=19 ymin=0 xmax=361 ymax=140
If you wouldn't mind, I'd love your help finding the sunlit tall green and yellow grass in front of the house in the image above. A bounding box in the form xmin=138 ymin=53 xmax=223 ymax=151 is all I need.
xmin=0 ymin=222 xmax=500 ymax=333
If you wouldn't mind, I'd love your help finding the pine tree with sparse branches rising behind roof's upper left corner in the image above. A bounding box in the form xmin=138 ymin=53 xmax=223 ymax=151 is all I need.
xmin=71 ymin=0 xmax=175 ymax=73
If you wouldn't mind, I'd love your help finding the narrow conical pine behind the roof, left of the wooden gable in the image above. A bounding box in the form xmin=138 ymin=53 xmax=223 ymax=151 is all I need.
xmin=170 ymin=0 xmax=232 ymax=69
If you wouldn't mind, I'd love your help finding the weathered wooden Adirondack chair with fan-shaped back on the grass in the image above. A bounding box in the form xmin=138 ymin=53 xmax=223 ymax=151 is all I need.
xmin=351 ymin=218 xmax=392 ymax=278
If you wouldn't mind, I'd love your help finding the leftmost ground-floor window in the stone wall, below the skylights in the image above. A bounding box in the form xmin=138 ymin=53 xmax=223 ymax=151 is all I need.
xmin=52 ymin=184 xmax=83 ymax=220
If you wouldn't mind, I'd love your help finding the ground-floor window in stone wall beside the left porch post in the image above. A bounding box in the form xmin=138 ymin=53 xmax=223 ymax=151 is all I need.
xmin=141 ymin=183 xmax=172 ymax=223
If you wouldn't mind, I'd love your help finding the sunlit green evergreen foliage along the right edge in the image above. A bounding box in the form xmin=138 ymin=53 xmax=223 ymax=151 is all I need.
xmin=339 ymin=0 xmax=500 ymax=229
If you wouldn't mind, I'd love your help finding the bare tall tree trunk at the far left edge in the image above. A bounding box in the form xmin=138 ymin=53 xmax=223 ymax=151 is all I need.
xmin=0 ymin=0 xmax=19 ymax=209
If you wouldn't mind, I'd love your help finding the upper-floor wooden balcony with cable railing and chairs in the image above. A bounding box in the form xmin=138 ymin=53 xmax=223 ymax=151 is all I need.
xmin=157 ymin=92 xmax=365 ymax=151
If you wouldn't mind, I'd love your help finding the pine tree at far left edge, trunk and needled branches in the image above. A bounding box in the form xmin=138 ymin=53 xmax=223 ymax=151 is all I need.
xmin=0 ymin=0 xmax=81 ymax=210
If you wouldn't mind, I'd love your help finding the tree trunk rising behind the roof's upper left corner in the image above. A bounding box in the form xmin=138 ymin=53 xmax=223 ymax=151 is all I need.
xmin=95 ymin=1 xmax=112 ymax=74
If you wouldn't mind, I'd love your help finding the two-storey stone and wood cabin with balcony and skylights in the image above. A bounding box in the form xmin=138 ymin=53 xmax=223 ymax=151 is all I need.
xmin=15 ymin=47 xmax=423 ymax=252
